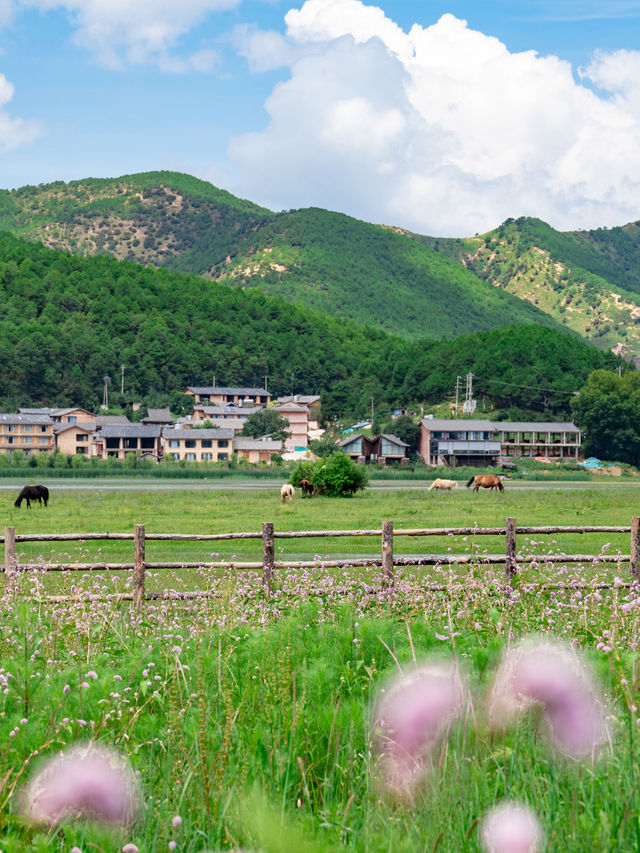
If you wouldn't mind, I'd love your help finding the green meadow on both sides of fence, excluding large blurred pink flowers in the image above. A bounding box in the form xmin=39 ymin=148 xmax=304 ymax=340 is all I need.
xmin=0 ymin=486 xmax=640 ymax=853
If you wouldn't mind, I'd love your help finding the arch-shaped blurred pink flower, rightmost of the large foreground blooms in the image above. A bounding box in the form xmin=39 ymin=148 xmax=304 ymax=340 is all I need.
xmin=489 ymin=641 xmax=608 ymax=758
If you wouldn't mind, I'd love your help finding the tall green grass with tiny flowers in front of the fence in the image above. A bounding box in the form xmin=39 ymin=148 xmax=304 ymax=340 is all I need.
xmin=0 ymin=579 xmax=640 ymax=853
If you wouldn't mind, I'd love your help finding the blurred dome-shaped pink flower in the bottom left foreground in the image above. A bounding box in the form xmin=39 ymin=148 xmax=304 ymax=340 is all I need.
xmin=22 ymin=743 xmax=138 ymax=826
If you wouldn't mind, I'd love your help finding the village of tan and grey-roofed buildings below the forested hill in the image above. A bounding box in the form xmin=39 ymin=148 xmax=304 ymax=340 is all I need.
xmin=0 ymin=386 xmax=582 ymax=467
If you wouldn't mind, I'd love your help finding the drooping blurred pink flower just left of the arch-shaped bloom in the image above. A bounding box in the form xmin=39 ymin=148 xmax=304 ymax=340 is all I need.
xmin=373 ymin=664 xmax=464 ymax=796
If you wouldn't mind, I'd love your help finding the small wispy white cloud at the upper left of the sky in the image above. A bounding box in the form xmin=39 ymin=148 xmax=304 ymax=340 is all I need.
xmin=21 ymin=0 xmax=241 ymax=72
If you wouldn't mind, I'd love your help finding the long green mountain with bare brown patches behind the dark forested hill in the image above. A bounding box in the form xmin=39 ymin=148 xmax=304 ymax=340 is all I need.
xmin=0 ymin=172 xmax=556 ymax=338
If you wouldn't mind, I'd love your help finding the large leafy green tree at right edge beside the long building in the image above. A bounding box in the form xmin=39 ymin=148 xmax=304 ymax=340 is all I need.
xmin=572 ymin=370 xmax=640 ymax=465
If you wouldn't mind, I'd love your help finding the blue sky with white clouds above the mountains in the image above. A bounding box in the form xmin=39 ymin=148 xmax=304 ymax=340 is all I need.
xmin=0 ymin=0 xmax=640 ymax=236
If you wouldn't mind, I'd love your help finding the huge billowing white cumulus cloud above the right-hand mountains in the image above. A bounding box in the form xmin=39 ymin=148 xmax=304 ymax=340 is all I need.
xmin=230 ymin=0 xmax=640 ymax=235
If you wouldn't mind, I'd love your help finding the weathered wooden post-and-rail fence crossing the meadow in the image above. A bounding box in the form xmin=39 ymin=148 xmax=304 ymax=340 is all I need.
xmin=0 ymin=517 xmax=640 ymax=605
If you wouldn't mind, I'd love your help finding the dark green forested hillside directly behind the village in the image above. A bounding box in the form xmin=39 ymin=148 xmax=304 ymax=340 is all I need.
xmin=0 ymin=234 xmax=619 ymax=416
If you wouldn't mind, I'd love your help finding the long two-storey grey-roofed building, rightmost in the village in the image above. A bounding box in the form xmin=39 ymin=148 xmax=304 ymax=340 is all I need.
xmin=420 ymin=417 xmax=581 ymax=465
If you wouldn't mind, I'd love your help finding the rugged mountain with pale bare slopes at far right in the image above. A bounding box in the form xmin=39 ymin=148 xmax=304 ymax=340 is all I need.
xmin=412 ymin=217 xmax=640 ymax=359
